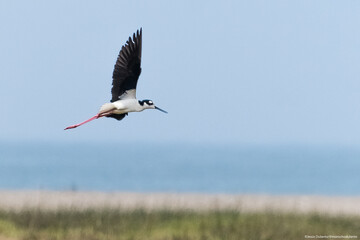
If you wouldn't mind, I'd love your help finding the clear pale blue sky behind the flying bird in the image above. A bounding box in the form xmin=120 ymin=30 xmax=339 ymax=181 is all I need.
xmin=0 ymin=0 xmax=360 ymax=146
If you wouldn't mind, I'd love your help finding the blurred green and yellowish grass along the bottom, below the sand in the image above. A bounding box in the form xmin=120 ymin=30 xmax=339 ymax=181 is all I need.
xmin=0 ymin=210 xmax=360 ymax=240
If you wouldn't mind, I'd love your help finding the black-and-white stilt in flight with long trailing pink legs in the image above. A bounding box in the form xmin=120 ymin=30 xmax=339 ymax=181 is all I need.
xmin=65 ymin=28 xmax=167 ymax=130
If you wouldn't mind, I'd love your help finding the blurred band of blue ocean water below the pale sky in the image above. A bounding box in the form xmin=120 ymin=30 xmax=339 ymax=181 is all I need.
xmin=0 ymin=143 xmax=360 ymax=195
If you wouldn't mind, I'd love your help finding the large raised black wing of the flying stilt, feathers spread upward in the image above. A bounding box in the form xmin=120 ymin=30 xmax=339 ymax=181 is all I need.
xmin=111 ymin=28 xmax=142 ymax=102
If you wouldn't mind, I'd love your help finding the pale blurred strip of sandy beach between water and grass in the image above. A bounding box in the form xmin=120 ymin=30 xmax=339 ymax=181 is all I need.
xmin=0 ymin=191 xmax=360 ymax=215
